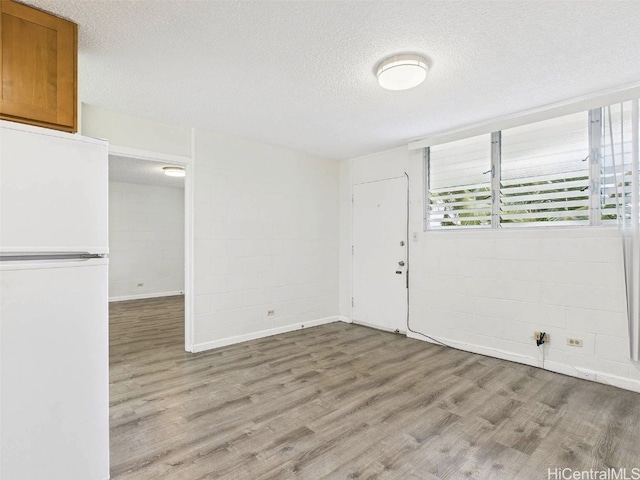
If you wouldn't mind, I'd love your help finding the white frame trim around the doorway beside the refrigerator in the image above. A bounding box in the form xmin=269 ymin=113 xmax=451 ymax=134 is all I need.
xmin=109 ymin=144 xmax=194 ymax=352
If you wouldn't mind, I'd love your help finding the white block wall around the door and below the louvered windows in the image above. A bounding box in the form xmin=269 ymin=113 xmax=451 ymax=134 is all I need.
xmin=340 ymin=149 xmax=640 ymax=391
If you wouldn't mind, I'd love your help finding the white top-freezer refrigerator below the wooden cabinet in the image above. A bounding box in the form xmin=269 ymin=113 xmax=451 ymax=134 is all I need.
xmin=0 ymin=121 xmax=109 ymax=480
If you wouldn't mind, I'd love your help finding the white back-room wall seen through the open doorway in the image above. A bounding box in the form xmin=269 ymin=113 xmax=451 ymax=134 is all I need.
xmin=109 ymin=182 xmax=184 ymax=301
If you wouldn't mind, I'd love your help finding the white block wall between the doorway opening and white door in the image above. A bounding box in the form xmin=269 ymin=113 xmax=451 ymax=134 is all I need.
xmin=193 ymin=130 xmax=339 ymax=351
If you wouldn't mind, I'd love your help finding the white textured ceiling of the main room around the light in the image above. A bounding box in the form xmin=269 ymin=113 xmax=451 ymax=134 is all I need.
xmin=26 ymin=0 xmax=640 ymax=158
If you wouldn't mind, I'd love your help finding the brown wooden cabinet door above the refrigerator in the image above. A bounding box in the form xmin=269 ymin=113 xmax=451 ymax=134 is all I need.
xmin=0 ymin=0 xmax=77 ymax=132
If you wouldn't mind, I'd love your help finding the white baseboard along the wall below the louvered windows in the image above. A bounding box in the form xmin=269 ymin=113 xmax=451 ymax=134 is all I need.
xmin=407 ymin=332 xmax=640 ymax=393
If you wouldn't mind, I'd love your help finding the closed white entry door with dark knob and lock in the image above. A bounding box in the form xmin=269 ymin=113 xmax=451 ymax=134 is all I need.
xmin=352 ymin=177 xmax=408 ymax=332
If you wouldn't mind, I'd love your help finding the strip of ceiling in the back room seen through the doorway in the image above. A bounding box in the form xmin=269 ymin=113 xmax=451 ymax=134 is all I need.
xmin=109 ymin=155 xmax=184 ymax=188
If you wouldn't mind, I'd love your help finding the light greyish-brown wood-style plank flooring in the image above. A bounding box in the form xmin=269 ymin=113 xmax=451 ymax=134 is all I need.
xmin=110 ymin=297 xmax=640 ymax=480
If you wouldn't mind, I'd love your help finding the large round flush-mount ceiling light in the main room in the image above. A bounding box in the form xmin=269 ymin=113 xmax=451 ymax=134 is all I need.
xmin=376 ymin=53 xmax=429 ymax=90
